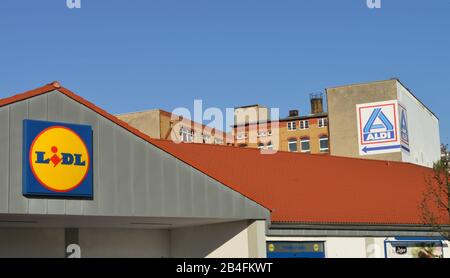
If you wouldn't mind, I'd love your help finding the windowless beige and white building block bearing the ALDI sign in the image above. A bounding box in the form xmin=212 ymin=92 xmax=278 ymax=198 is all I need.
xmin=326 ymin=79 xmax=440 ymax=167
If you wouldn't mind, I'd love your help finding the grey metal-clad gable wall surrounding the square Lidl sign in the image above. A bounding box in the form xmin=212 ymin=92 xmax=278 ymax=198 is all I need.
xmin=0 ymin=91 xmax=269 ymax=219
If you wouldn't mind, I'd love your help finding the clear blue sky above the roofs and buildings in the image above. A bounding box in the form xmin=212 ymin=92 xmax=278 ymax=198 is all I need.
xmin=0 ymin=0 xmax=450 ymax=143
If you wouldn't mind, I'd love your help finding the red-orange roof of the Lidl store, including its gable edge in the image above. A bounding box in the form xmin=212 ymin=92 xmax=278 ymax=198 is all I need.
xmin=0 ymin=83 xmax=442 ymax=224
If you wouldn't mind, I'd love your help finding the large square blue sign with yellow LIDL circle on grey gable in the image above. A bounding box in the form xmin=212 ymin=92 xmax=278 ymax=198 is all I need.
xmin=23 ymin=120 xmax=93 ymax=198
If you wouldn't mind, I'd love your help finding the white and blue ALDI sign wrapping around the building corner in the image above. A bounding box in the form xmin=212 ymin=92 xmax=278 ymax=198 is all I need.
xmin=356 ymin=100 xmax=409 ymax=155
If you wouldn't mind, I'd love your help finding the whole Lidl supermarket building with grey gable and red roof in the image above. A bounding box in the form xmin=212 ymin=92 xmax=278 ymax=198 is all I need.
xmin=0 ymin=82 xmax=450 ymax=258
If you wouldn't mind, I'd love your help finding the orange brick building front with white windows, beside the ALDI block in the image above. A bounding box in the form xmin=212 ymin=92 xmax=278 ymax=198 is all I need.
xmin=233 ymin=94 xmax=329 ymax=154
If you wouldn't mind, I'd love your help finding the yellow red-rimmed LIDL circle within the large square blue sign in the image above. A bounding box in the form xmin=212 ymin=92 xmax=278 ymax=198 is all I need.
xmin=29 ymin=126 xmax=90 ymax=192
